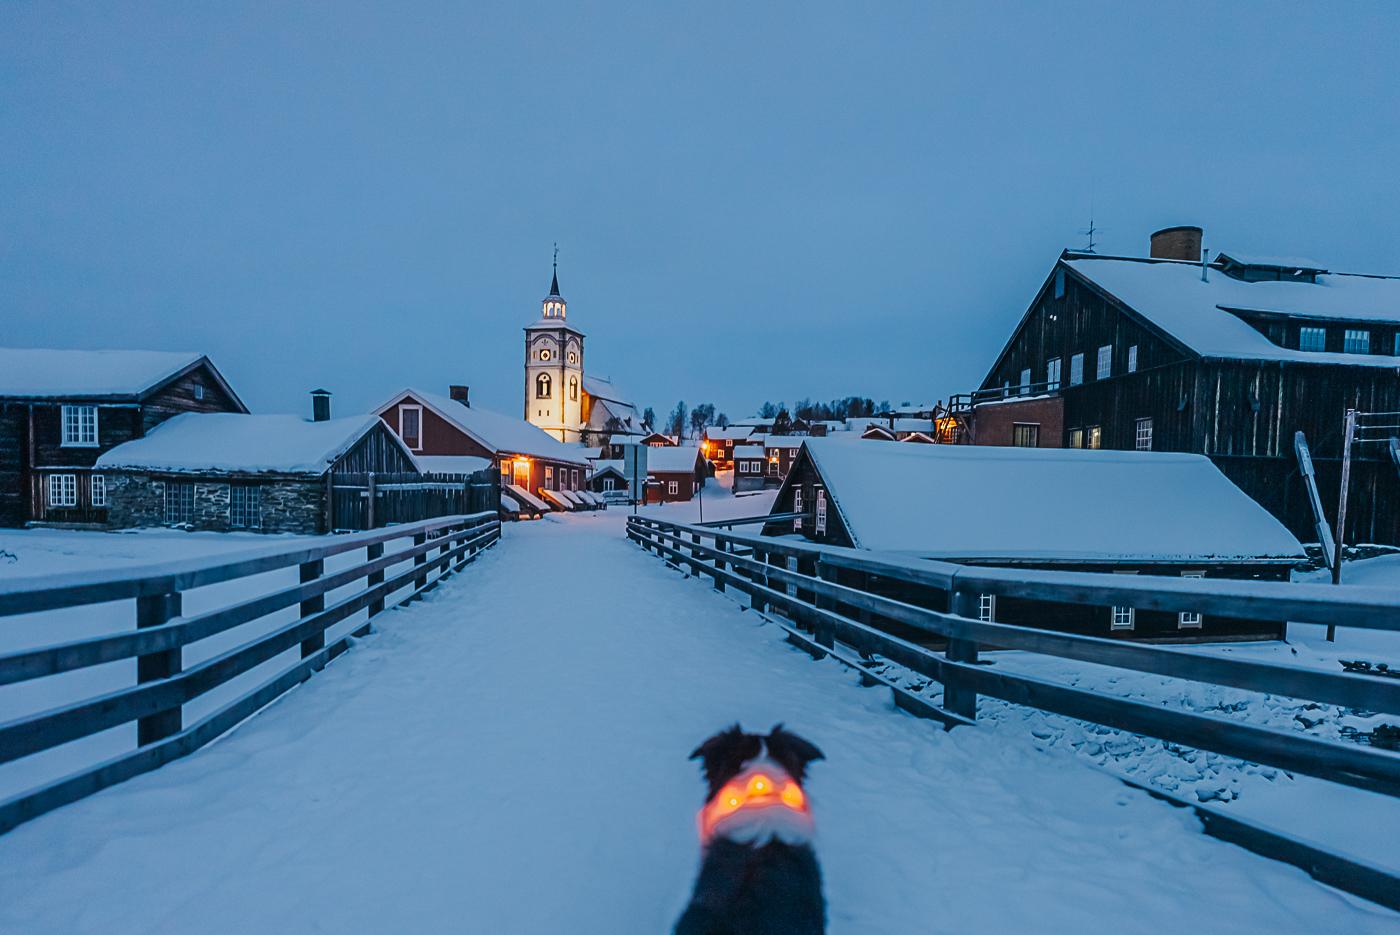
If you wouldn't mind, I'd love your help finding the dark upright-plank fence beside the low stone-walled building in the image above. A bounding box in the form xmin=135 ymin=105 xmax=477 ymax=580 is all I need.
xmin=326 ymin=468 xmax=501 ymax=530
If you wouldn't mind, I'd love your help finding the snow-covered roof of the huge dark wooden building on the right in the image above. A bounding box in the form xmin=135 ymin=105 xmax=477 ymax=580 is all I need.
xmin=1064 ymin=256 xmax=1400 ymax=367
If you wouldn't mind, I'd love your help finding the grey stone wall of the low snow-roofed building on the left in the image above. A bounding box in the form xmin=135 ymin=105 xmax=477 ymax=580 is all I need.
xmin=106 ymin=472 xmax=326 ymax=535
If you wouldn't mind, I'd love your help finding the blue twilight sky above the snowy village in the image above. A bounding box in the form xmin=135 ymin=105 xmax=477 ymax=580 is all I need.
xmin=0 ymin=0 xmax=1400 ymax=416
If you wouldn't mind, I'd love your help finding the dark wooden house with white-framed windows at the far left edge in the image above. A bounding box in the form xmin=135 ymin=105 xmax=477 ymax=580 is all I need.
xmin=0 ymin=347 xmax=248 ymax=526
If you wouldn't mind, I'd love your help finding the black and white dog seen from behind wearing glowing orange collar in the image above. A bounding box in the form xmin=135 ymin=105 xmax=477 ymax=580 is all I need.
xmin=675 ymin=724 xmax=826 ymax=935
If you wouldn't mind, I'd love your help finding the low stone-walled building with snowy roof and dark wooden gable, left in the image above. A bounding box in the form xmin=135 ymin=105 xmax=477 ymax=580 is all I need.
xmin=97 ymin=409 xmax=421 ymax=535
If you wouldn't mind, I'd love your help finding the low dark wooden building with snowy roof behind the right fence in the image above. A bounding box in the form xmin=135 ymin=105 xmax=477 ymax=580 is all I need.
xmin=763 ymin=440 xmax=1303 ymax=642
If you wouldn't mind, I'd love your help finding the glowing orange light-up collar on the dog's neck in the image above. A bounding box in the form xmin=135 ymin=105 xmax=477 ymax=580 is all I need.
xmin=697 ymin=763 xmax=812 ymax=844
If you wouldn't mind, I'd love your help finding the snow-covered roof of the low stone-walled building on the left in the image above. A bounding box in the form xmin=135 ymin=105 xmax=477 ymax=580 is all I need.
xmin=97 ymin=413 xmax=407 ymax=474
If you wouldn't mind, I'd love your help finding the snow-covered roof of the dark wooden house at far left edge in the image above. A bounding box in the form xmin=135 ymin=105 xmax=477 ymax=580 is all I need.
xmin=0 ymin=347 xmax=221 ymax=399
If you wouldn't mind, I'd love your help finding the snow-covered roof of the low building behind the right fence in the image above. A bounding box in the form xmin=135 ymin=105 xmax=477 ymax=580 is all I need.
xmin=806 ymin=438 xmax=1303 ymax=561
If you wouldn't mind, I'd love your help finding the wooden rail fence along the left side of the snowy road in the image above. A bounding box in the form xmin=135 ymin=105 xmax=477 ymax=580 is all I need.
xmin=0 ymin=511 xmax=500 ymax=833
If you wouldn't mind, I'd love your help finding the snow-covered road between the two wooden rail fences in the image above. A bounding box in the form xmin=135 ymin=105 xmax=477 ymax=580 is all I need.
xmin=0 ymin=511 xmax=1397 ymax=935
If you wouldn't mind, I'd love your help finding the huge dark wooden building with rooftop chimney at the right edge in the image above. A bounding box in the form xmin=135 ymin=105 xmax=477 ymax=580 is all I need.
xmin=958 ymin=228 xmax=1400 ymax=544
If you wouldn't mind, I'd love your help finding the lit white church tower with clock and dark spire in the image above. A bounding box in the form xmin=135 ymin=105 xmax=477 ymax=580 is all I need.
xmin=525 ymin=246 xmax=584 ymax=441
